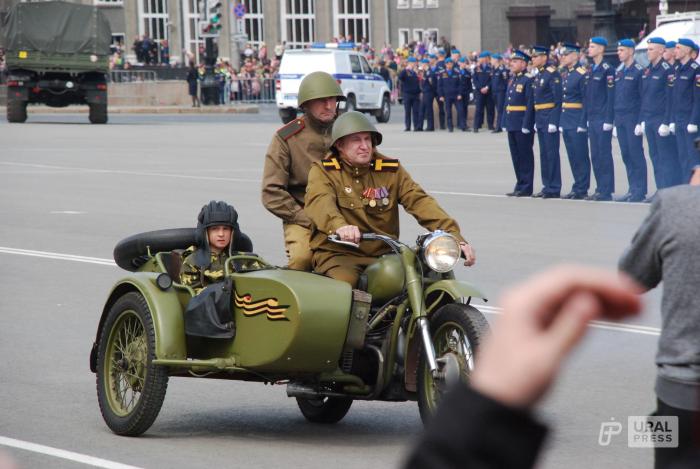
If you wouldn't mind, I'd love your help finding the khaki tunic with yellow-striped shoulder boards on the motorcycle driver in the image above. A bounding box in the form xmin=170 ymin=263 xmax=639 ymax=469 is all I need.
xmin=304 ymin=150 xmax=464 ymax=280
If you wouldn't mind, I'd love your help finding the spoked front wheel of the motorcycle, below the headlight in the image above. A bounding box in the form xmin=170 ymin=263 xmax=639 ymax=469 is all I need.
xmin=418 ymin=303 xmax=489 ymax=423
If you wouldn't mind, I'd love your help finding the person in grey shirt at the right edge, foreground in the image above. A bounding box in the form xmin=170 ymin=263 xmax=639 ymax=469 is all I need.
xmin=619 ymin=181 xmax=700 ymax=468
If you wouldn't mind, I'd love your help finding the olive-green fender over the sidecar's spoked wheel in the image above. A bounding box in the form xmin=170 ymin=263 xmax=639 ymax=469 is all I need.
xmin=90 ymin=272 xmax=187 ymax=372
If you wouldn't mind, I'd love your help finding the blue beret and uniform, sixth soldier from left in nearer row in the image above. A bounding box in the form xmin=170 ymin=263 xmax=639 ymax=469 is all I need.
xmin=640 ymin=37 xmax=681 ymax=189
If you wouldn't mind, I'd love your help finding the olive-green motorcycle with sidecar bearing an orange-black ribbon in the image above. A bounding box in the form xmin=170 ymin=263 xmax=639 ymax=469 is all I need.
xmin=90 ymin=228 xmax=489 ymax=436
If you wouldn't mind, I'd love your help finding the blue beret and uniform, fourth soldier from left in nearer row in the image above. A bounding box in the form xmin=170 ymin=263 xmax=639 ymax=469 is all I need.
xmin=583 ymin=37 xmax=615 ymax=200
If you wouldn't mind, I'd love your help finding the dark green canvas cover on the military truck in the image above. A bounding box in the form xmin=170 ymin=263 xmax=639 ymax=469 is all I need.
xmin=0 ymin=2 xmax=112 ymax=70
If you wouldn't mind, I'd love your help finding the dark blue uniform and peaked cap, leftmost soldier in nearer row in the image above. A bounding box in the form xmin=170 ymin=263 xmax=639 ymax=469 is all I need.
xmin=503 ymin=51 xmax=535 ymax=197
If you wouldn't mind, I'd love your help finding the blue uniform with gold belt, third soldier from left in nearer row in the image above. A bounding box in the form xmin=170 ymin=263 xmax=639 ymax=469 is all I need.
xmin=559 ymin=44 xmax=591 ymax=199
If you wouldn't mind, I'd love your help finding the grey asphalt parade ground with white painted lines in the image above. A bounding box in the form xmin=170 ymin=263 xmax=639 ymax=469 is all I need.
xmin=0 ymin=107 xmax=660 ymax=468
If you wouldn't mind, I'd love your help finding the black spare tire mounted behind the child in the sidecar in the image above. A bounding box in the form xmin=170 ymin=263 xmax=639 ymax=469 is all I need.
xmin=113 ymin=228 xmax=253 ymax=272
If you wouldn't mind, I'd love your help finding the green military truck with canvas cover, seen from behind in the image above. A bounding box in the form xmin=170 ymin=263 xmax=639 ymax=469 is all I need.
xmin=0 ymin=1 xmax=112 ymax=124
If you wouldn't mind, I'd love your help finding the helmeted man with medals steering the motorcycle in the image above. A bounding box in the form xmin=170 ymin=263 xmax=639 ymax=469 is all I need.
xmin=305 ymin=112 xmax=476 ymax=287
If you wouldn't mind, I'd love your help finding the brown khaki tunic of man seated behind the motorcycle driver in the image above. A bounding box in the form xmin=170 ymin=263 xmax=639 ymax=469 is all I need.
xmin=262 ymin=116 xmax=331 ymax=228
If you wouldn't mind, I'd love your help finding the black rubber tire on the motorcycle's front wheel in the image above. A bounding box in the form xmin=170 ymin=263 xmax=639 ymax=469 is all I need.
xmin=417 ymin=303 xmax=489 ymax=424
